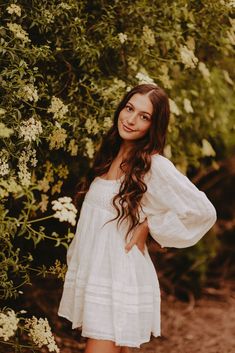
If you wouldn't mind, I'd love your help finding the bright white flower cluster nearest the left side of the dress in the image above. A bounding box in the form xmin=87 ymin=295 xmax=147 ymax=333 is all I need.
xmin=52 ymin=196 xmax=77 ymax=226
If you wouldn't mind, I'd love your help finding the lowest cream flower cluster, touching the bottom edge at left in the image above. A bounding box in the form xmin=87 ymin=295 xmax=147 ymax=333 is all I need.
xmin=25 ymin=316 xmax=60 ymax=353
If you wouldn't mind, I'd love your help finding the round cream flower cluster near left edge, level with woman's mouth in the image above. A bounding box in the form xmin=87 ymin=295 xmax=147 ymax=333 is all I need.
xmin=19 ymin=117 xmax=42 ymax=142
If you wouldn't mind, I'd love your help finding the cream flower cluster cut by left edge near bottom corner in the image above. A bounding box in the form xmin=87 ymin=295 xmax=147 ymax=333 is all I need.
xmin=0 ymin=310 xmax=19 ymax=341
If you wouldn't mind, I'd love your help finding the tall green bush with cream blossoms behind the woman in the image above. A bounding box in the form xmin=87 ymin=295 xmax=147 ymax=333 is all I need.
xmin=0 ymin=0 xmax=235 ymax=350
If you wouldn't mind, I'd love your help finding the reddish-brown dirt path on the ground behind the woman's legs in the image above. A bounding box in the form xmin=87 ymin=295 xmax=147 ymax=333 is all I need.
xmin=57 ymin=293 xmax=235 ymax=353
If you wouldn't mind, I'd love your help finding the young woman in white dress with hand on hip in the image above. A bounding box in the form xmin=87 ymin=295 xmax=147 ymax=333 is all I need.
xmin=59 ymin=84 xmax=216 ymax=353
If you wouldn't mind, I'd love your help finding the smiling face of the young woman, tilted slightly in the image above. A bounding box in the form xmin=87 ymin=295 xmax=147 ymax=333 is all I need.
xmin=118 ymin=93 xmax=153 ymax=141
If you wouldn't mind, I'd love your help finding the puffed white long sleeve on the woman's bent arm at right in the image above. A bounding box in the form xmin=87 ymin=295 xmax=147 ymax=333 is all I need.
xmin=142 ymin=155 xmax=216 ymax=248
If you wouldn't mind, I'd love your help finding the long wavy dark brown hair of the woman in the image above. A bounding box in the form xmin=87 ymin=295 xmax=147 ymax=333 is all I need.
xmin=76 ymin=84 xmax=170 ymax=239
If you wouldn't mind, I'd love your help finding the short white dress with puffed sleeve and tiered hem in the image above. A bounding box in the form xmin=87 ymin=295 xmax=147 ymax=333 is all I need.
xmin=58 ymin=155 xmax=216 ymax=347
